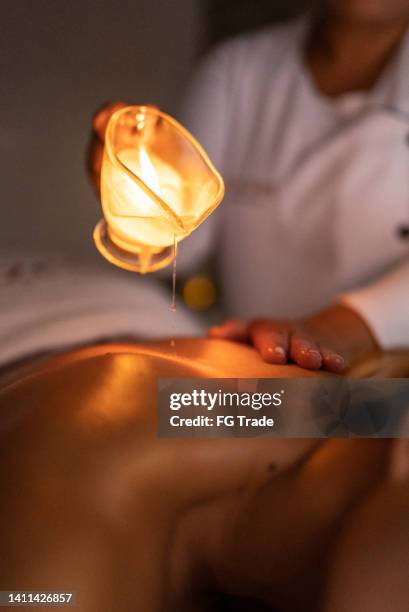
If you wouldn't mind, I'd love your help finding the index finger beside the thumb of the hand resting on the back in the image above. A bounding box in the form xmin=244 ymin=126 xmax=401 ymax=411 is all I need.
xmin=249 ymin=321 xmax=289 ymax=365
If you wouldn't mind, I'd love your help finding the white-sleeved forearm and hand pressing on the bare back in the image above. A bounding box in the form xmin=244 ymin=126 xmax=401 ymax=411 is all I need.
xmin=210 ymin=260 xmax=409 ymax=372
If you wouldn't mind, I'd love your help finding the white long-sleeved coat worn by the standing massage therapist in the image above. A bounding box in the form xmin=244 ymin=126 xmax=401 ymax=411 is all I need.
xmin=180 ymin=20 xmax=409 ymax=348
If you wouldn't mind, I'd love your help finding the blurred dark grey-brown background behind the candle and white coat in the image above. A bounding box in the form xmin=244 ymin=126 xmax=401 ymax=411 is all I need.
xmin=0 ymin=0 xmax=307 ymax=257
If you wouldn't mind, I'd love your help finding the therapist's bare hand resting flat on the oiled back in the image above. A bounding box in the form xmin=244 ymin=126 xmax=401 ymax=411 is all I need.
xmin=209 ymin=304 xmax=378 ymax=374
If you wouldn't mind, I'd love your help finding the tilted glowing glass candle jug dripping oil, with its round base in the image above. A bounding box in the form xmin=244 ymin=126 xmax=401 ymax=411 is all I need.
xmin=94 ymin=106 xmax=224 ymax=273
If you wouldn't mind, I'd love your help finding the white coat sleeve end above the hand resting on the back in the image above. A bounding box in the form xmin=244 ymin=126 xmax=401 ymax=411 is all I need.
xmin=341 ymin=259 xmax=409 ymax=350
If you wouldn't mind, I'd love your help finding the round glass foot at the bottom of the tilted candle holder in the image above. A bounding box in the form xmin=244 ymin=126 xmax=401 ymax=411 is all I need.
xmin=94 ymin=219 xmax=175 ymax=274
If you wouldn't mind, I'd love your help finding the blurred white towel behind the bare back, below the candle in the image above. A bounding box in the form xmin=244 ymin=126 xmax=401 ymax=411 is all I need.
xmin=0 ymin=257 xmax=204 ymax=366
